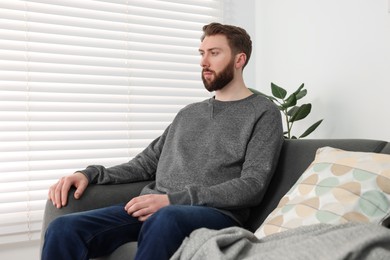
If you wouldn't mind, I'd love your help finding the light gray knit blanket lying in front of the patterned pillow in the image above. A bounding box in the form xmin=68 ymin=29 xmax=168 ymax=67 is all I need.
xmin=171 ymin=223 xmax=390 ymax=260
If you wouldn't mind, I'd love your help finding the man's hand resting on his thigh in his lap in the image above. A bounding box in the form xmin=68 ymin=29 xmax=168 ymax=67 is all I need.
xmin=125 ymin=194 xmax=169 ymax=221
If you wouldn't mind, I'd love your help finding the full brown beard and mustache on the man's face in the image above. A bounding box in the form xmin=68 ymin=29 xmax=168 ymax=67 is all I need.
xmin=202 ymin=59 xmax=234 ymax=92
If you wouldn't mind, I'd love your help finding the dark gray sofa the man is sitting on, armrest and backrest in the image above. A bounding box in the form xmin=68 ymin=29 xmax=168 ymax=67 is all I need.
xmin=41 ymin=139 xmax=390 ymax=259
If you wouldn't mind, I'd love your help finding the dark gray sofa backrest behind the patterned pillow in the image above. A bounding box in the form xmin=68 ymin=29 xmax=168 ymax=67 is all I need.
xmin=245 ymin=139 xmax=390 ymax=231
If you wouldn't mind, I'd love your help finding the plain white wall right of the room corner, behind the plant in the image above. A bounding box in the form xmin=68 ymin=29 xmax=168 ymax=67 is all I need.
xmin=255 ymin=0 xmax=390 ymax=141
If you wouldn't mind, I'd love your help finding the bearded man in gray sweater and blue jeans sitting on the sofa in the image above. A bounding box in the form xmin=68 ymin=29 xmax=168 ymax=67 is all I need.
xmin=42 ymin=23 xmax=283 ymax=260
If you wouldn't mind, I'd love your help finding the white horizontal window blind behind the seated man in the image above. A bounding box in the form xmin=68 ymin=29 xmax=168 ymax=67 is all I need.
xmin=0 ymin=0 xmax=222 ymax=244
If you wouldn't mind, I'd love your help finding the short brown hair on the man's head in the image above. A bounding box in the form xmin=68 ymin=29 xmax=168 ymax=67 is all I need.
xmin=201 ymin=23 xmax=252 ymax=67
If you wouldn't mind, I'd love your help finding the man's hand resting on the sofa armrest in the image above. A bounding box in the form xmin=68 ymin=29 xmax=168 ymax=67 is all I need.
xmin=49 ymin=172 xmax=88 ymax=208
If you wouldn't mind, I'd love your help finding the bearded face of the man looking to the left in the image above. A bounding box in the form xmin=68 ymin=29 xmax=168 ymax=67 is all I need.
xmin=199 ymin=35 xmax=234 ymax=92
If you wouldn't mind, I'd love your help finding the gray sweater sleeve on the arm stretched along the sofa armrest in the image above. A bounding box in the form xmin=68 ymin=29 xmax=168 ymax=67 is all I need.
xmin=79 ymin=127 xmax=169 ymax=184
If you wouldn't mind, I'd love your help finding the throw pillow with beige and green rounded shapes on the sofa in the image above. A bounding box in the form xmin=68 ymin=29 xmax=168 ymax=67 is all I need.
xmin=255 ymin=147 xmax=390 ymax=238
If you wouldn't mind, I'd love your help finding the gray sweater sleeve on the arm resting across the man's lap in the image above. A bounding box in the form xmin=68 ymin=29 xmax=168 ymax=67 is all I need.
xmin=168 ymin=105 xmax=284 ymax=210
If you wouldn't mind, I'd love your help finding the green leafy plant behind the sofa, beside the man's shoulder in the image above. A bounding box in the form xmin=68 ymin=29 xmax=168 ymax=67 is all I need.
xmin=250 ymin=83 xmax=323 ymax=139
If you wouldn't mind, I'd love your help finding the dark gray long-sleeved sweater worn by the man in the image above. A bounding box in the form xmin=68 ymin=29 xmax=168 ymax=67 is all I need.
xmin=81 ymin=95 xmax=283 ymax=224
